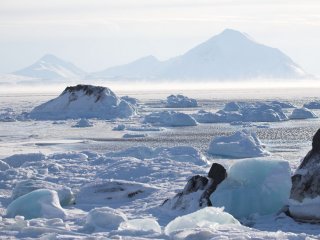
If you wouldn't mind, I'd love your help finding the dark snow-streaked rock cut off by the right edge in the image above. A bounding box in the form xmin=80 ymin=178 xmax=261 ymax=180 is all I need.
xmin=290 ymin=129 xmax=320 ymax=202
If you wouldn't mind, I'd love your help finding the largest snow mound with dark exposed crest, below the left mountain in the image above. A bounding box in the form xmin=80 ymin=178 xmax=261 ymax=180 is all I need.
xmin=30 ymin=85 xmax=135 ymax=120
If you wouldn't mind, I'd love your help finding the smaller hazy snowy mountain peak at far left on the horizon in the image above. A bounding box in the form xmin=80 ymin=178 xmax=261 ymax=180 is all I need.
xmin=13 ymin=54 xmax=86 ymax=80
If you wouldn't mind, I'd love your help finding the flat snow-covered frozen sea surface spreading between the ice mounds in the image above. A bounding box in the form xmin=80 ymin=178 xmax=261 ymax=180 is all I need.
xmin=0 ymin=89 xmax=320 ymax=239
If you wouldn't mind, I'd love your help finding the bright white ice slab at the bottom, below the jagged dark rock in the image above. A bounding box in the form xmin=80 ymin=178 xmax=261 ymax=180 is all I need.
xmin=164 ymin=207 xmax=240 ymax=236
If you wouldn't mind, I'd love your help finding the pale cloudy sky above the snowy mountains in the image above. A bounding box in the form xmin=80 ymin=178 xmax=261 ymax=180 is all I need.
xmin=0 ymin=0 xmax=320 ymax=76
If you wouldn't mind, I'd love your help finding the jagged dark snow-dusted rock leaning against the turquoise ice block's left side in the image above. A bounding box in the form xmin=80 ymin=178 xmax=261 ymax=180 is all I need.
xmin=162 ymin=163 xmax=227 ymax=210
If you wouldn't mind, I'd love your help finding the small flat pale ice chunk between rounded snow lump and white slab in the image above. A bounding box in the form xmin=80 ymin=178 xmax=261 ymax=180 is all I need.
xmin=119 ymin=218 xmax=161 ymax=233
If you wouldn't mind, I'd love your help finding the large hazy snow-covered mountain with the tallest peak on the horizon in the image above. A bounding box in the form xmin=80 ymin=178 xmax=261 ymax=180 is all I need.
xmin=91 ymin=29 xmax=309 ymax=80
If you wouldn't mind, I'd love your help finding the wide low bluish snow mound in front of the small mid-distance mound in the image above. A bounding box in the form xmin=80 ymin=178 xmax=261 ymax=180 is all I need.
xmin=144 ymin=111 xmax=197 ymax=127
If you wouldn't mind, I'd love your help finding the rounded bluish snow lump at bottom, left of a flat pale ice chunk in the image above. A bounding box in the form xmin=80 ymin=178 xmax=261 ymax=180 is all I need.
xmin=84 ymin=207 xmax=127 ymax=233
